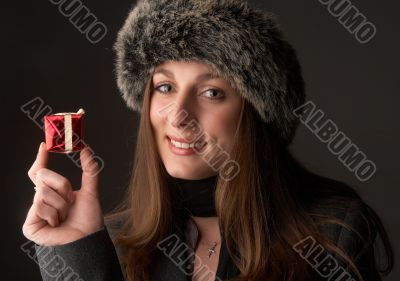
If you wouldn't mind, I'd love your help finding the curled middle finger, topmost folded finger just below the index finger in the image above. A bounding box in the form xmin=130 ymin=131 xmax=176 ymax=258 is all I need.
xmin=36 ymin=168 xmax=74 ymax=203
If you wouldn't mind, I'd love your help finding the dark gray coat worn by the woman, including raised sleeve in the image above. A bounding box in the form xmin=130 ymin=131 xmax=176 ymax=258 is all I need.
xmin=35 ymin=200 xmax=381 ymax=281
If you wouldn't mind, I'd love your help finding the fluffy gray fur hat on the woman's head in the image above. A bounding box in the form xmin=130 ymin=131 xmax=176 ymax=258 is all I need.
xmin=114 ymin=0 xmax=305 ymax=145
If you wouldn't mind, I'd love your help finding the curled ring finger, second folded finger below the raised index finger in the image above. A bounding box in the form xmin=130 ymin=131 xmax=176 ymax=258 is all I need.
xmin=33 ymin=185 xmax=68 ymax=221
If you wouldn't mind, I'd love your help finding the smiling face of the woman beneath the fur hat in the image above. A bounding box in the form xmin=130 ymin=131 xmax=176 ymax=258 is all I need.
xmin=150 ymin=61 xmax=242 ymax=179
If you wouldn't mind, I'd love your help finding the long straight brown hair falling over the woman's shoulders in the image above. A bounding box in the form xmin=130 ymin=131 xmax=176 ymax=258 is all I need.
xmin=106 ymin=72 xmax=393 ymax=281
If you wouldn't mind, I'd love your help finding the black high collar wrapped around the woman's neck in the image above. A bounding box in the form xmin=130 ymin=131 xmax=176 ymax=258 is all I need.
xmin=171 ymin=175 xmax=218 ymax=217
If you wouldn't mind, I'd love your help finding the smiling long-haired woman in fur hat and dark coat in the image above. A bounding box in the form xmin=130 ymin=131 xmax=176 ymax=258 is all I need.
xmin=23 ymin=0 xmax=393 ymax=281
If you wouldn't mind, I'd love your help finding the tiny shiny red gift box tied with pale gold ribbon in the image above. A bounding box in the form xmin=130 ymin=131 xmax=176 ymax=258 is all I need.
xmin=44 ymin=108 xmax=85 ymax=153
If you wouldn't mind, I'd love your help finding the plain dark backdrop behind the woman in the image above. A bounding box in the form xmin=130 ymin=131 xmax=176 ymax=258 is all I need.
xmin=0 ymin=0 xmax=400 ymax=281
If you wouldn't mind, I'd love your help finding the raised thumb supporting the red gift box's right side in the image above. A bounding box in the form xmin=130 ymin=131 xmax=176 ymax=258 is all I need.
xmin=80 ymin=146 xmax=100 ymax=197
